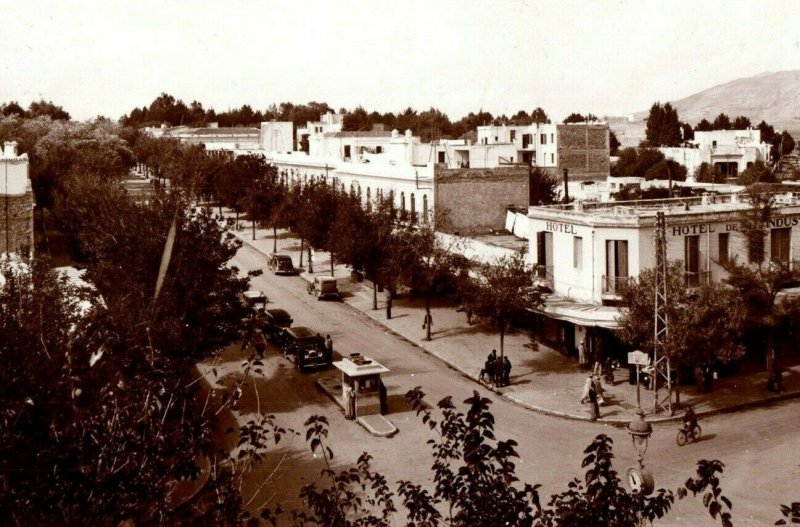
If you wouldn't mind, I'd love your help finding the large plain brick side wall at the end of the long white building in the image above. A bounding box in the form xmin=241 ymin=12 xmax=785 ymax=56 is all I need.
xmin=434 ymin=166 xmax=528 ymax=234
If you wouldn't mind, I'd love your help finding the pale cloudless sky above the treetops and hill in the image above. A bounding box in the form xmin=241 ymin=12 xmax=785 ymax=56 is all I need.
xmin=0 ymin=0 xmax=800 ymax=120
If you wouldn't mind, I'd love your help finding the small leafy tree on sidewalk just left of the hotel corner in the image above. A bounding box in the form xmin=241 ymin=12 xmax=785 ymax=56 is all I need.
xmin=467 ymin=253 xmax=543 ymax=360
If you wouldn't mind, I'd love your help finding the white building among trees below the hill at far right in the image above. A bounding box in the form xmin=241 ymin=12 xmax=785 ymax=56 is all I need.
xmin=658 ymin=128 xmax=770 ymax=177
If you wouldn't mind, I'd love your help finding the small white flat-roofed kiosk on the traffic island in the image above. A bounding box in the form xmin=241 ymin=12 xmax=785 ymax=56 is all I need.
xmin=333 ymin=353 xmax=389 ymax=419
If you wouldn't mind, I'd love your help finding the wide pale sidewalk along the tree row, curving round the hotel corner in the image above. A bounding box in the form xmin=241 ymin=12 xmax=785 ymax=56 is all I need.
xmin=228 ymin=222 xmax=800 ymax=426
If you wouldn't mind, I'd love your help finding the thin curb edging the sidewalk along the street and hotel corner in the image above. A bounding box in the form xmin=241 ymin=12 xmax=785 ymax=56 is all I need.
xmin=237 ymin=229 xmax=800 ymax=428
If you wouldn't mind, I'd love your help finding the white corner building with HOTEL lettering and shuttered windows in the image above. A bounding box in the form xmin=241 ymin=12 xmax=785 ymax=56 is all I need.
xmin=528 ymin=193 xmax=800 ymax=364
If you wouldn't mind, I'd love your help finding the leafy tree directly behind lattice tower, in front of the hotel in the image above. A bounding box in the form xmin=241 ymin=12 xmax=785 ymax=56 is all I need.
xmin=620 ymin=261 xmax=745 ymax=404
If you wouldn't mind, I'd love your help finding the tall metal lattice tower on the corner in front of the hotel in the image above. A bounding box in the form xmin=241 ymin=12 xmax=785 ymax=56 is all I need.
xmin=652 ymin=212 xmax=672 ymax=415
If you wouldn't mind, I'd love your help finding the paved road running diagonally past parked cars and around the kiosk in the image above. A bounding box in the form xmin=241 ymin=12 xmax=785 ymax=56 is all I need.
xmin=227 ymin=245 xmax=800 ymax=525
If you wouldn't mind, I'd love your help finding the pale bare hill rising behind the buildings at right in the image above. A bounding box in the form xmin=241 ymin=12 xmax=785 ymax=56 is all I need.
xmin=606 ymin=70 xmax=800 ymax=147
